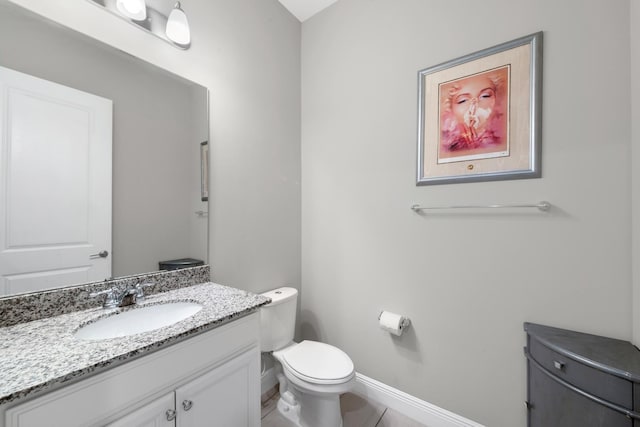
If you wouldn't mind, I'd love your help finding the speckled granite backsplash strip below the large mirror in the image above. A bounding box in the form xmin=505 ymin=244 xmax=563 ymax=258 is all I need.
xmin=0 ymin=265 xmax=211 ymax=327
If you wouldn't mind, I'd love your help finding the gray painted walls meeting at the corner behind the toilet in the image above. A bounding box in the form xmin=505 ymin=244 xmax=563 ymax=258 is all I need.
xmin=11 ymin=0 xmax=638 ymax=427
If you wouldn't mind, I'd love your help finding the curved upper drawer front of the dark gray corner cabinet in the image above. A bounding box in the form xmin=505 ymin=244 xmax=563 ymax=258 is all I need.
xmin=529 ymin=337 xmax=633 ymax=409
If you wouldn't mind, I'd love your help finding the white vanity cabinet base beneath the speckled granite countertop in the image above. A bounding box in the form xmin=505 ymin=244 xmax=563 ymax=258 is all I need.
xmin=4 ymin=312 xmax=260 ymax=427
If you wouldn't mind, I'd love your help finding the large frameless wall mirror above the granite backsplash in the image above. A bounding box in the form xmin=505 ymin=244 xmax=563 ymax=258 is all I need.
xmin=0 ymin=0 xmax=209 ymax=297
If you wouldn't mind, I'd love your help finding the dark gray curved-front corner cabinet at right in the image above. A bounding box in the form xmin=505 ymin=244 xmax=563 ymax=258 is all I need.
xmin=524 ymin=323 xmax=640 ymax=427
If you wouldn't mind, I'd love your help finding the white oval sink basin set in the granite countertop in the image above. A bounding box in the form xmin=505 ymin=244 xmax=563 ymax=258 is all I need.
xmin=75 ymin=301 xmax=202 ymax=340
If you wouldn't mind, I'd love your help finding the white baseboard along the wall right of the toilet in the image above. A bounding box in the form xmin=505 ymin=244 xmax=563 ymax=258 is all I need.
xmin=353 ymin=373 xmax=484 ymax=427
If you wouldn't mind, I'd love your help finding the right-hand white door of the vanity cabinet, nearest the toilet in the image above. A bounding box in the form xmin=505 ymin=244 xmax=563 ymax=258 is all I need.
xmin=176 ymin=347 xmax=260 ymax=427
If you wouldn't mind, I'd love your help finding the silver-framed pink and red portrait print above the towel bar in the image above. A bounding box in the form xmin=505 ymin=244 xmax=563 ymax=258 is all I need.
xmin=417 ymin=32 xmax=542 ymax=185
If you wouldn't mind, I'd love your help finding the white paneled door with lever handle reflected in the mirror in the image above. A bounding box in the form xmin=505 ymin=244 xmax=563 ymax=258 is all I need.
xmin=0 ymin=67 xmax=113 ymax=295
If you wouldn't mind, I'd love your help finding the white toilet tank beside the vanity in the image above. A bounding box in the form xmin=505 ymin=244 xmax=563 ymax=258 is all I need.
xmin=260 ymin=288 xmax=298 ymax=351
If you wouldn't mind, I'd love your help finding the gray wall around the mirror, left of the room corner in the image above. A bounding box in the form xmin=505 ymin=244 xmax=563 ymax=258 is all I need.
xmin=5 ymin=0 xmax=300 ymax=291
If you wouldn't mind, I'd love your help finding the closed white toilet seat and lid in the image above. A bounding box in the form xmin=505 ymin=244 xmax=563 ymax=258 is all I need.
xmin=274 ymin=341 xmax=354 ymax=385
